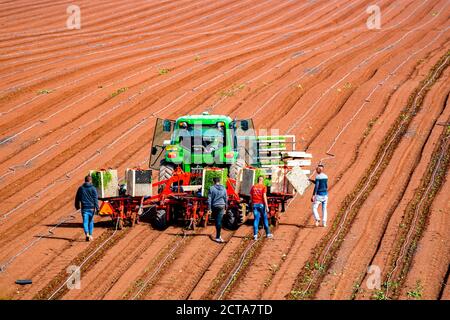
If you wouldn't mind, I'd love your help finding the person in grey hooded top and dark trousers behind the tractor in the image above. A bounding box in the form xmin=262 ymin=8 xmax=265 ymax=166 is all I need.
xmin=208 ymin=178 xmax=228 ymax=243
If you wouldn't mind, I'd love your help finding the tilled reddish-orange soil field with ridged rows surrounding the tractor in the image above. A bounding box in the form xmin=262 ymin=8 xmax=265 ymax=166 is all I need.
xmin=0 ymin=0 xmax=450 ymax=299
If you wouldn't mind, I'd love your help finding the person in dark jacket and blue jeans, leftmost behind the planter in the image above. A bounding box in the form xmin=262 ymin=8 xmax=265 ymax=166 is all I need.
xmin=75 ymin=176 xmax=99 ymax=241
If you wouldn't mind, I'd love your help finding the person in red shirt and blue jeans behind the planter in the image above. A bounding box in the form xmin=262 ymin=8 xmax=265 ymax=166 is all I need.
xmin=250 ymin=176 xmax=273 ymax=240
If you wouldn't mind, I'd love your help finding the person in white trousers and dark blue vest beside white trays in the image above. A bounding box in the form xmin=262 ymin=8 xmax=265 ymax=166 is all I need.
xmin=310 ymin=164 xmax=328 ymax=227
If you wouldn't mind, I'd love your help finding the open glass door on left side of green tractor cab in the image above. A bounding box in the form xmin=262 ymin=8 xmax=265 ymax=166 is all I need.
xmin=149 ymin=119 xmax=175 ymax=170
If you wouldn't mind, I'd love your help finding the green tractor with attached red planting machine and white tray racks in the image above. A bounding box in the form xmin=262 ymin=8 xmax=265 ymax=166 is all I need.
xmin=97 ymin=114 xmax=311 ymax=230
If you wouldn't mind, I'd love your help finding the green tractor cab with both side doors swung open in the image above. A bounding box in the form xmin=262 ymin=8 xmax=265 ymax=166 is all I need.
xmin=149 ymin=113 xmax=258 ymax=178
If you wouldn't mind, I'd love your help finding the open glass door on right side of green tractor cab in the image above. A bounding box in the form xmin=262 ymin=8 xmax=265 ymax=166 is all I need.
xmin=234 ymin=119 xmax=258 ymax=165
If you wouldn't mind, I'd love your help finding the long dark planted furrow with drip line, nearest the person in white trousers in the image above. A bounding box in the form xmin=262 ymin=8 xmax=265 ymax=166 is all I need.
xmin=290 ymin=50 xmax=450 ymax=299
